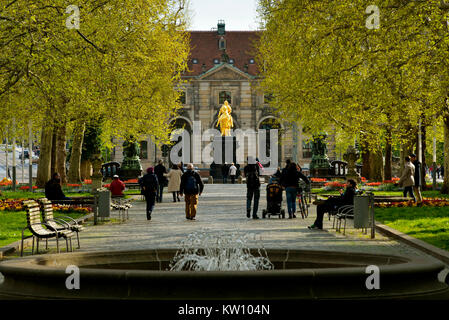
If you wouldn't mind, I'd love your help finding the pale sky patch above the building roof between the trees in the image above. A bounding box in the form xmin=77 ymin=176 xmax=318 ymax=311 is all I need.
xmin=189 ymin=0 xmax=258 ymax=31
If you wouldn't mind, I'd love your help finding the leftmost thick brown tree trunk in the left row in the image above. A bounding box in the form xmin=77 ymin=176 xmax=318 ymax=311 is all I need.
xmin=36 ymin=126 xmax=53 ymax=188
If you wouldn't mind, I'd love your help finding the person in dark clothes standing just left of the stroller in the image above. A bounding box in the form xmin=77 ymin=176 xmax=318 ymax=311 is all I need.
xmin=243 ymin=158 xmax=260 ymax=219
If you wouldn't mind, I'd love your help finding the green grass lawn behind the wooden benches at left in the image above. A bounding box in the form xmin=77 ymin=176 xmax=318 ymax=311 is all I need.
xmin=0 ymin=211 xmax=84 ymax=247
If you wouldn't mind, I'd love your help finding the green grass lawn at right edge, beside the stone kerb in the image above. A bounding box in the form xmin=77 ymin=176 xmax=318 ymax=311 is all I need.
xmin=375 ymin=207 xmax=449 ymax=250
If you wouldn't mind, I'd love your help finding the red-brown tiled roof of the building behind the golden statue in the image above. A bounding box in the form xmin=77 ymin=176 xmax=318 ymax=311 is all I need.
xmin=184 ymin=30 xmax=261 ymax=76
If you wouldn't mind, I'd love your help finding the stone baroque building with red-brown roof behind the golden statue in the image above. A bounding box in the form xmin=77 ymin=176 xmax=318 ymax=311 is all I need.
xmin=113 ymin=21 xmax=335 ymax=174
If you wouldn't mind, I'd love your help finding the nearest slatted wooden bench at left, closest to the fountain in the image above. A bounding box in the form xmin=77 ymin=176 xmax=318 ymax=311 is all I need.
xmin=20 ymin=200 xmax=73 ymax=256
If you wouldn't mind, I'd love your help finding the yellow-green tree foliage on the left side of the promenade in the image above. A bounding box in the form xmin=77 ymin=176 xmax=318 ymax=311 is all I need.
xmin=0 ymin=0 xmax=189 ymax=141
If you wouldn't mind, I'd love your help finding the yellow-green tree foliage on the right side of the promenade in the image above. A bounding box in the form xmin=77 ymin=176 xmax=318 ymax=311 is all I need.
xmin=258 ymin=0 xmax=449 ymax=150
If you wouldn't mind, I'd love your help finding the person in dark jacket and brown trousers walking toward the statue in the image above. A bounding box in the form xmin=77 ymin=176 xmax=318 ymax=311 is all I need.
xmin=179 ymin=163 xmax=204 ymax=220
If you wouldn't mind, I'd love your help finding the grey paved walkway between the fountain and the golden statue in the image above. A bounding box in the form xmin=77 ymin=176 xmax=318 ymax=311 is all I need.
xmin=77 ymin=184 xmax=433 ymax=259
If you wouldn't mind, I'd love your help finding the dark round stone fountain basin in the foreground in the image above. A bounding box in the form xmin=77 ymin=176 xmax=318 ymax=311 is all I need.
xmin=0 ymin=249 xmax=449 ymax=300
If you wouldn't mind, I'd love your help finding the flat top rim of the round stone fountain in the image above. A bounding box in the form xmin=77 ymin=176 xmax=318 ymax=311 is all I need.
xmin=0 ymin=248 xmax=444 ymax=276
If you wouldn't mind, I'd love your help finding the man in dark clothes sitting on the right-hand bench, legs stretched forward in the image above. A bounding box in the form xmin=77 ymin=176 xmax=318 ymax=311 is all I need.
xmin=308 ymin=179 xmax=357 ymax=229
